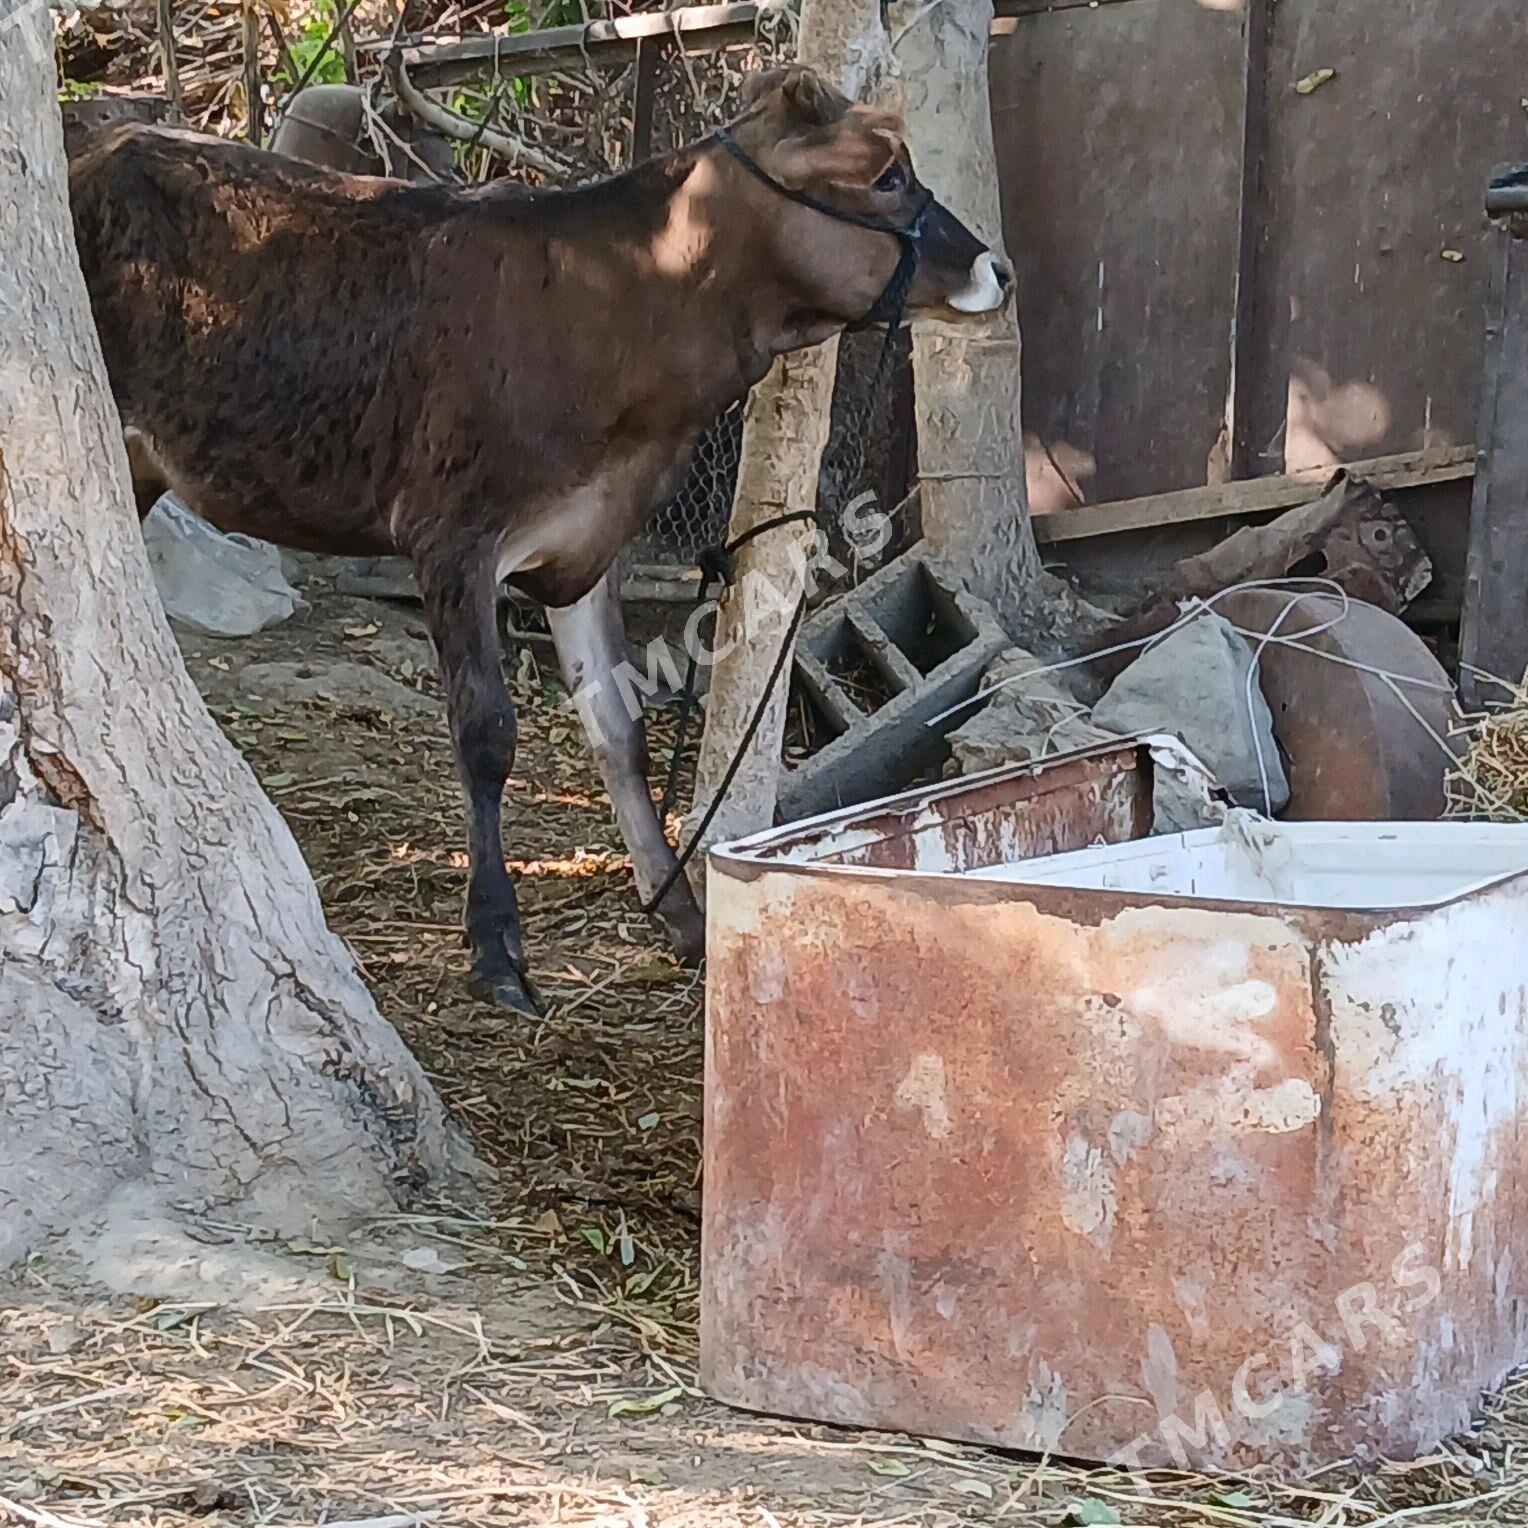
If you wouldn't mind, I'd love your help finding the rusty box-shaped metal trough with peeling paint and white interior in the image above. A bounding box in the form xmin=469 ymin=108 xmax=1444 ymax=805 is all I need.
xmin=701 ymin=744 xmax=1528 ymax=1470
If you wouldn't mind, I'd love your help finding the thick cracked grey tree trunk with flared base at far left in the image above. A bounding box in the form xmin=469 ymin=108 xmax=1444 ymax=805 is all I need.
xmin=0 ymin=17 xmax=457 ymax=1264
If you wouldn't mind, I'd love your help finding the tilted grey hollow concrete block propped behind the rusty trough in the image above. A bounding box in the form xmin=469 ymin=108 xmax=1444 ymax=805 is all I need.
xmin=779 ymin=542 xmax=1010 ymax=822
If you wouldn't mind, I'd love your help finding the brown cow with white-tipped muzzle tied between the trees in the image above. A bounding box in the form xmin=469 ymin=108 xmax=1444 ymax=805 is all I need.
xmin=72 ymin=67 xmax=1008 ymax=1013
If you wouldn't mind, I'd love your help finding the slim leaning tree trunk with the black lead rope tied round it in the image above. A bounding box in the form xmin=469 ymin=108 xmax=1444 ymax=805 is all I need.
xmin=691 ymin=0 xmax=894 ymax=861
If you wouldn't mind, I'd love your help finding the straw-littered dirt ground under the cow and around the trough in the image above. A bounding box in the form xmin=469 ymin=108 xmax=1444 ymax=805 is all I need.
xmin=0 ymin=579 xmax=1528 ymax=1528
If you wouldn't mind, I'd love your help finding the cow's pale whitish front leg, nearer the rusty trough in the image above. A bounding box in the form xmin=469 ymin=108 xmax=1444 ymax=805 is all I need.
xmin=547 ymin=570 xmax=706 ymax=966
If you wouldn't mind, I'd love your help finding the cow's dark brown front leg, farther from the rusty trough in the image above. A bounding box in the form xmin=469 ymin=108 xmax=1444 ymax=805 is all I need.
xmin=414 ymin=549 xmax=541 ymax=1018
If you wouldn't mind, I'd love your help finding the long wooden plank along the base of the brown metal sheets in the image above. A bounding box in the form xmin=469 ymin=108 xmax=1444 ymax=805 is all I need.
xmin=1034 ymin=446 xmax=1475 ymax=544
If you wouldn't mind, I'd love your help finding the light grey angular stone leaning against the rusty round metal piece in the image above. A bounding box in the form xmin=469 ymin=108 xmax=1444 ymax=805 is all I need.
xmin=1093 ymin=611 xmax=1290 ymax=825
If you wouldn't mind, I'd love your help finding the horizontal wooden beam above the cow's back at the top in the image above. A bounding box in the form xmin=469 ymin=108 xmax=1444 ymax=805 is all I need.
xmin=382 ymin=0 xmax=761 ymax=89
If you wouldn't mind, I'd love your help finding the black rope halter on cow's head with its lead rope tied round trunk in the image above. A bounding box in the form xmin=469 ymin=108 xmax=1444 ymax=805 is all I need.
xmin=643 ymin=128 xmax=934 ymax=914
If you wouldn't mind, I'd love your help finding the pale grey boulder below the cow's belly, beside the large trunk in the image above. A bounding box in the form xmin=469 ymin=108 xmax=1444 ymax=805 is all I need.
xmin=144 ymin=494 xmax=307 ymax=637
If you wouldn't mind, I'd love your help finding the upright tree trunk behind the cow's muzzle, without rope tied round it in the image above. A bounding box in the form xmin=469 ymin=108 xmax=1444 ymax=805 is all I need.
xmin=891 ymin=0 xmax=1041 ymax=636
